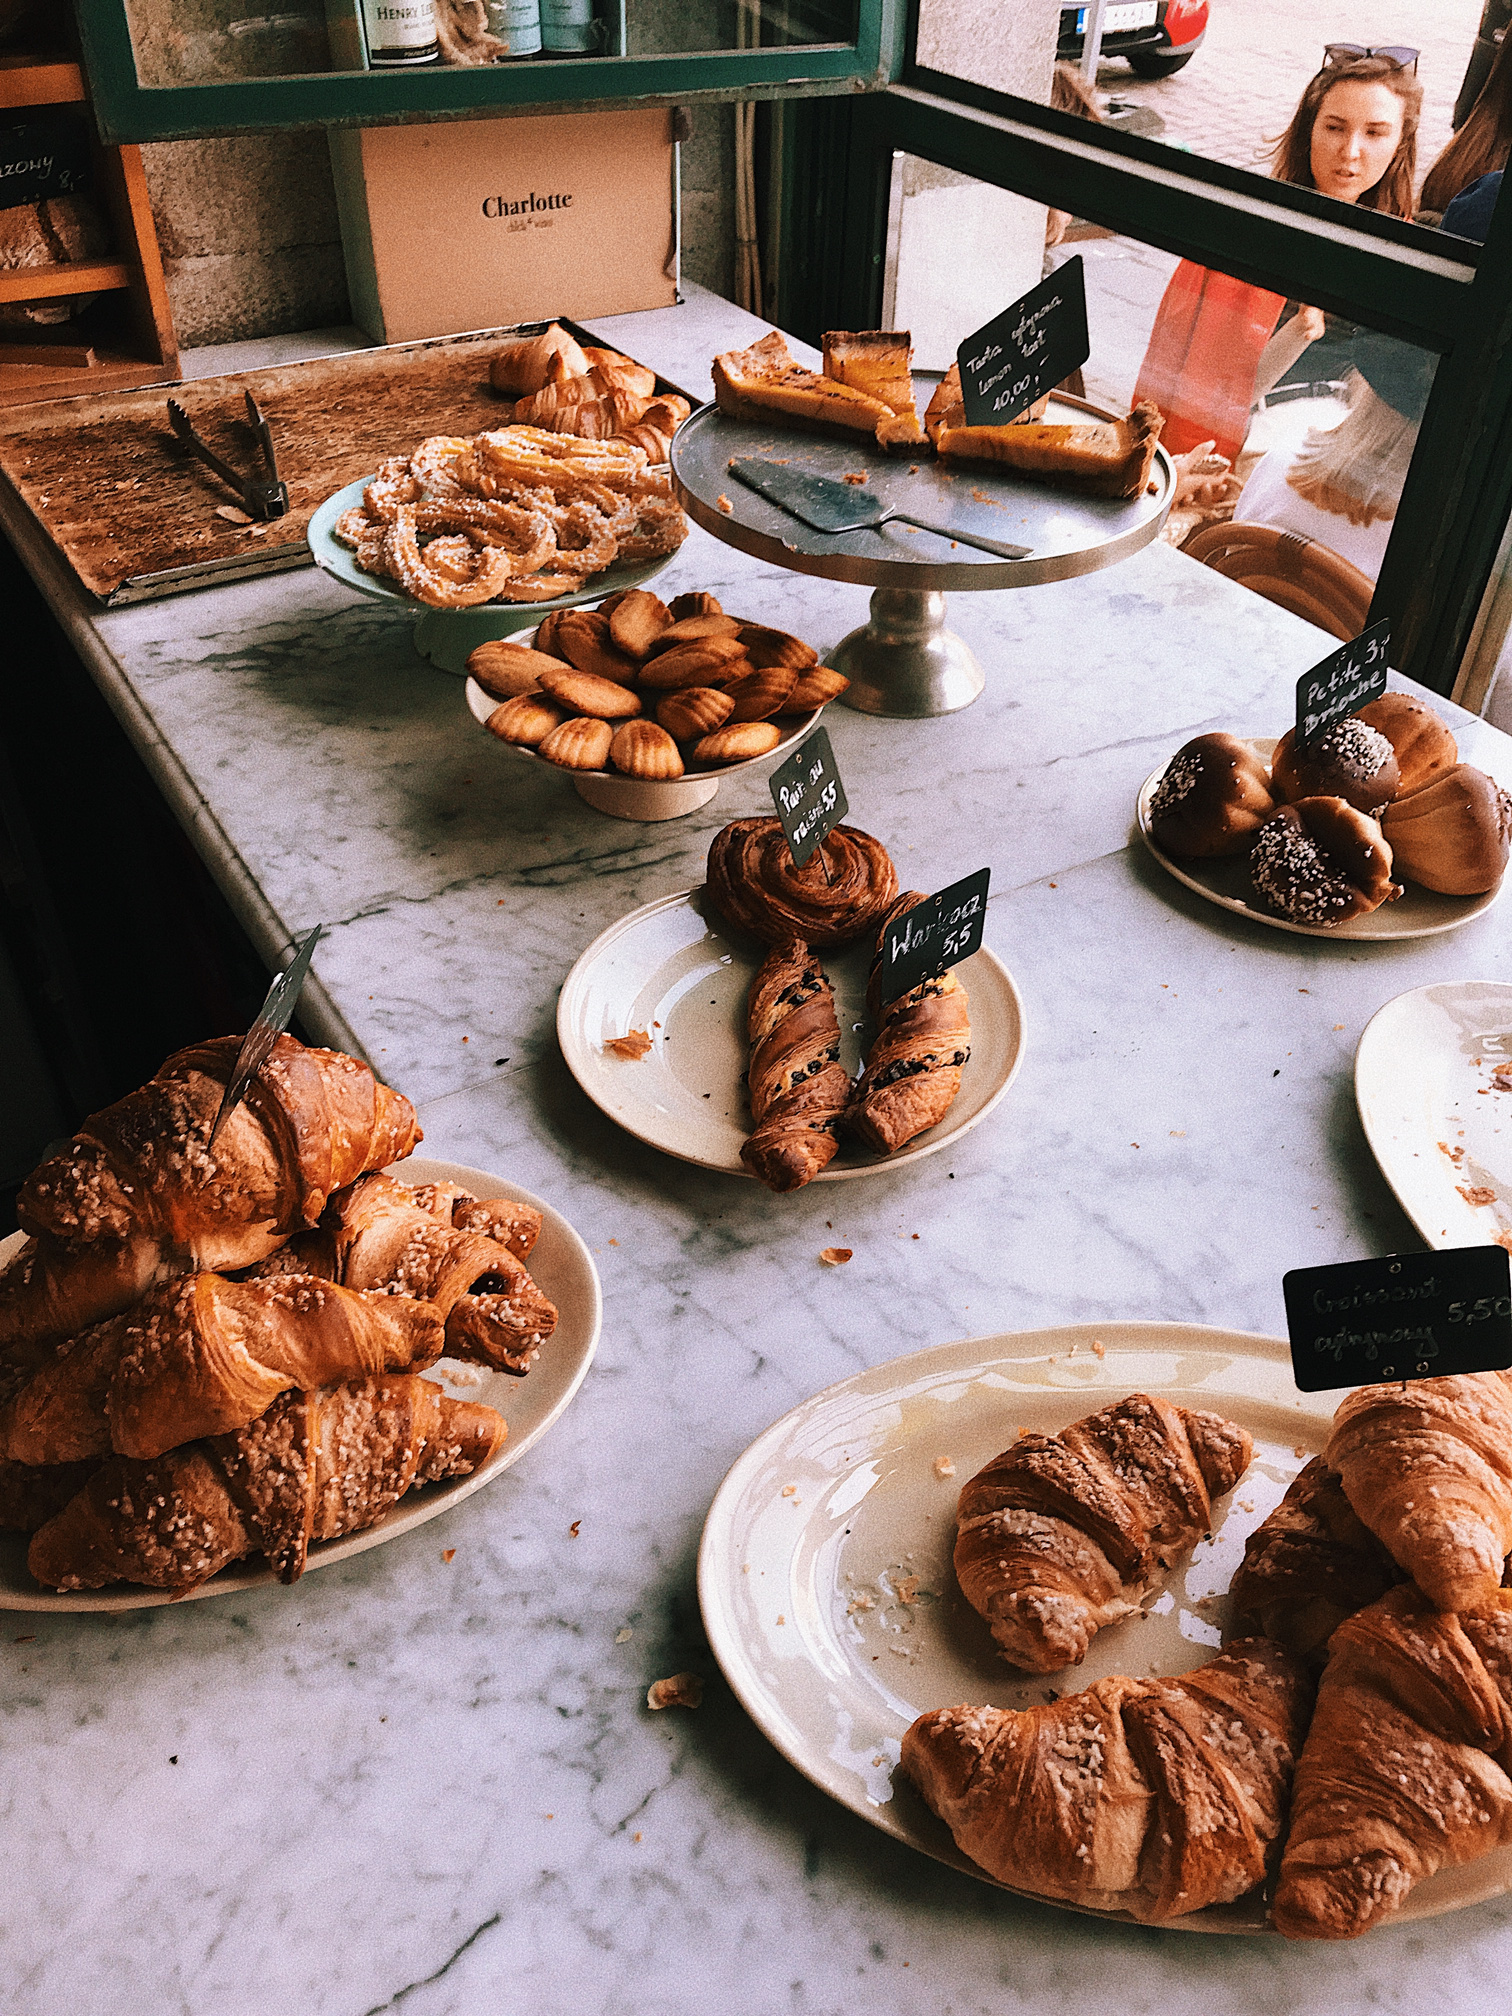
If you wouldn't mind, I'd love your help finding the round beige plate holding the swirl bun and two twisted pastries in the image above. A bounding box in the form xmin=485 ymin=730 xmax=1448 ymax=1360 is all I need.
xmin=556 ymin=889 xmax=1024 ymax=1183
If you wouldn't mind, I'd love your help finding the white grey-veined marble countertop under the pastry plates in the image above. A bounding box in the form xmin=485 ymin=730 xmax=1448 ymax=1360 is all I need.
xmin=0 ymin=296 xmax=1512 ymax=2016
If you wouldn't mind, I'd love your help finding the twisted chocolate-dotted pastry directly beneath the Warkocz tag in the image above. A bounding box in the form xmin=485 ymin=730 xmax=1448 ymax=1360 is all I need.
xmin=845 ymin=889 xmax=972 ymax=1155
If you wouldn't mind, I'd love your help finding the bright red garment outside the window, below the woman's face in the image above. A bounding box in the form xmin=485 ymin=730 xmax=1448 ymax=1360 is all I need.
xmin=1135 ymin=258 xmax=1286 ymax=462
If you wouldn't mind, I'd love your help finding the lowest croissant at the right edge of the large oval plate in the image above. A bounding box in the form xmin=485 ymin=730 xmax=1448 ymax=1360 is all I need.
xmin=1272 ymin=1585 xmax=1512 ymax=1939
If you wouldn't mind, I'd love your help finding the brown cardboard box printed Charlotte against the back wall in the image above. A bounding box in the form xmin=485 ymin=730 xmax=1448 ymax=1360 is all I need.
xmin=331 ymin=109 xmax=677 ymax=343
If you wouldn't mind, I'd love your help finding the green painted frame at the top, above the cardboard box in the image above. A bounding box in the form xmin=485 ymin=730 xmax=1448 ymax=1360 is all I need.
xmin=79 ymin=0 xmax=905 ymax=145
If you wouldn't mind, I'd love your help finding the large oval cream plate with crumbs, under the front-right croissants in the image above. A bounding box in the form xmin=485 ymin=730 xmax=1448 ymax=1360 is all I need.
xmin=698 ymin=1322 xmax=1512 ymax=1931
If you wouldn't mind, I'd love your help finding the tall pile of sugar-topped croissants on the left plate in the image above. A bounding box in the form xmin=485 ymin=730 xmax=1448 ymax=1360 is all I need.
xmin=0 ymin=1036 xmax=556 ymax=1595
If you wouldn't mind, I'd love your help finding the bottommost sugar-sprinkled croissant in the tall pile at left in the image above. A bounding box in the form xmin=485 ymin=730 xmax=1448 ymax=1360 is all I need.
xmin=26 ymin=1373 xmax=506 ymax=1595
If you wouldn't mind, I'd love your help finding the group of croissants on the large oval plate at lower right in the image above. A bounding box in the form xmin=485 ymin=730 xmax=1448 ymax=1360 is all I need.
xmin=901 ymin=1373 xmax=1512 ymax=1939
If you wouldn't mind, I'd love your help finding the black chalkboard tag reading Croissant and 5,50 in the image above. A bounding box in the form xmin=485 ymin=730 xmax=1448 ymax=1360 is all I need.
xmin=1282 ymin=1246 xmax=1512 ymax=1393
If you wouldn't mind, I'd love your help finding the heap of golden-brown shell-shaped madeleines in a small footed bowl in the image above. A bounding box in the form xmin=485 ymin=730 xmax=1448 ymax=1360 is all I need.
xmin=468 ymin=589 xmax=851 ymax=782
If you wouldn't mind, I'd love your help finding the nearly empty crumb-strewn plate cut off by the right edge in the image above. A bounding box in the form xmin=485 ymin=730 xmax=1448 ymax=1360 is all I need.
xmin=1355 ymin=980 xmax=1512 ymax=1248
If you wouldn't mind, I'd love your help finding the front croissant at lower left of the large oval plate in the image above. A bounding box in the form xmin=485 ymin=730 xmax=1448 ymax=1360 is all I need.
xmin=901 ymin=1639 xmax=1310 ymax=1921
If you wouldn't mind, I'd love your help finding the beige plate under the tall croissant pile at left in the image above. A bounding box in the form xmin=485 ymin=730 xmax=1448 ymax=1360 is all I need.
xmin=0 ymin=1155 xmax=603 ymax=1611
